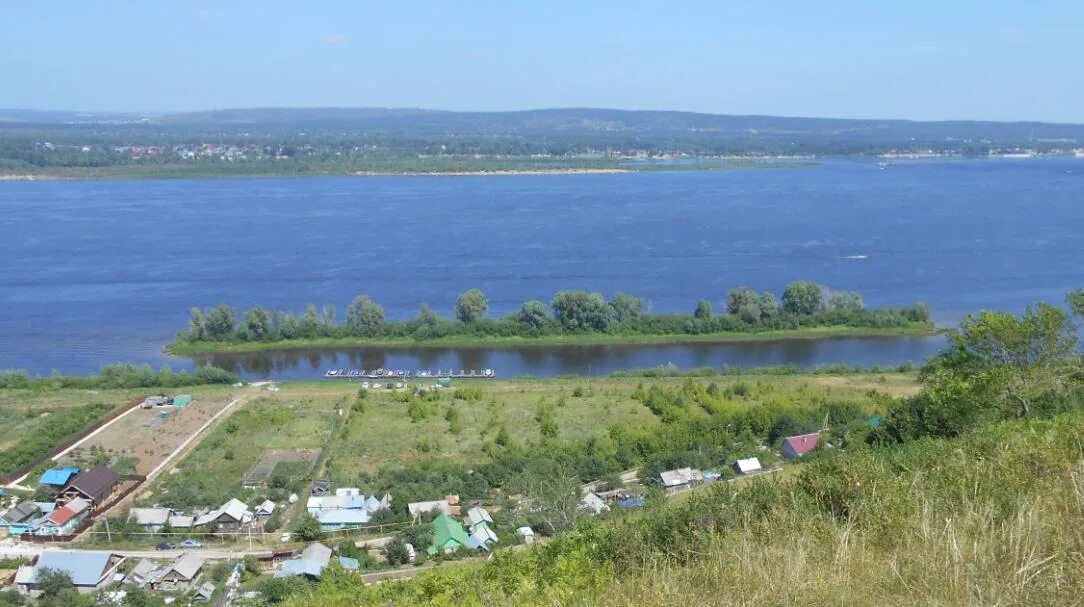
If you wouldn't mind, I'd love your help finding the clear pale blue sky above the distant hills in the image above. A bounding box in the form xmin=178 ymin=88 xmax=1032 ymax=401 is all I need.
xmin=0 ymin=0 xmax=1084 ymax=122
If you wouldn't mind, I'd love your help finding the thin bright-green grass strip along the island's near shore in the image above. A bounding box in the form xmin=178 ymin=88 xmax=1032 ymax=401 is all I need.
xmin=166 ymin=323 xmax=937 ymax=357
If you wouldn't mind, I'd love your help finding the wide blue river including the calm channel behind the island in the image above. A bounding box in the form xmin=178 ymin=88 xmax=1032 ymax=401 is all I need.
xmin=0 ymin=158 xmax=1084 ymax=377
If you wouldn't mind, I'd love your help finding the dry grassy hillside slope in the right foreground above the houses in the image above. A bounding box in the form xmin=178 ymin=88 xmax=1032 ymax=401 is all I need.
xmin=287 ymin=411 xmax=1084 ymax=607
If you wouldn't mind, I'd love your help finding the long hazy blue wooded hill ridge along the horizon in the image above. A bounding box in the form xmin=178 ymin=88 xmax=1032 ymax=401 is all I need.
xmin=6 ymin=107 xmax=1084 ymax=146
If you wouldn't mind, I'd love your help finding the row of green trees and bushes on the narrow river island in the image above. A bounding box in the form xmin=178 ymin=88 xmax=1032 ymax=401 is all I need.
xmin=177 ymin=281 xmax=930 ymax=343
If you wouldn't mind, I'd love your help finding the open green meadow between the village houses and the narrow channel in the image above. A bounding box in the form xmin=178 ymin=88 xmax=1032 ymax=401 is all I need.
xmin=143 ymin=374 xmax=917 ymax=494
